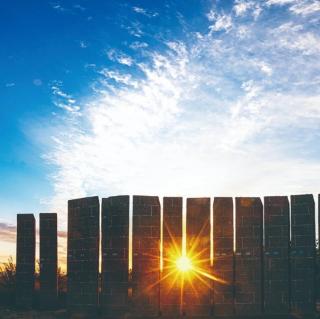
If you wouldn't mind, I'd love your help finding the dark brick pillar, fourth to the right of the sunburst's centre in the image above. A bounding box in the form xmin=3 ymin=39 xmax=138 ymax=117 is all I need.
xmin=264 ymin=196 xmax=290 ymax=314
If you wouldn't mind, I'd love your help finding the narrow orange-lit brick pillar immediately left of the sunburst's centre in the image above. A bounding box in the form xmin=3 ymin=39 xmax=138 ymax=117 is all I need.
xmin=161 ymin=197 xmax=182 ymax=317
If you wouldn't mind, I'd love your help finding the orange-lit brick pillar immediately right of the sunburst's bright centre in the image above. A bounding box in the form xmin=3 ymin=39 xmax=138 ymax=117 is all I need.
xmin=183 ymin=198 xmax=212 ymax=317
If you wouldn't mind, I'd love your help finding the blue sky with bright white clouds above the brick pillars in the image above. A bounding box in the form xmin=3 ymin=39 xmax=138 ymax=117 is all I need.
xmin=0 ymin=0 xmax=320 ymax=268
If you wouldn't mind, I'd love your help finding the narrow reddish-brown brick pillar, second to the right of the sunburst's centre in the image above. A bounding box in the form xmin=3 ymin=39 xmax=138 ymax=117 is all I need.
xmin=213 ymin=197 xmax=234 ymax=316
